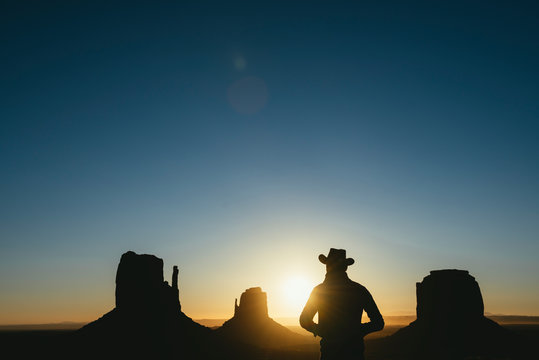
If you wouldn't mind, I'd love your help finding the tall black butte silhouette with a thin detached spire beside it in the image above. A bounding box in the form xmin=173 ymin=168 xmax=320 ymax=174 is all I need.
xmin=77 ymin=251 xmax=214 ymax=358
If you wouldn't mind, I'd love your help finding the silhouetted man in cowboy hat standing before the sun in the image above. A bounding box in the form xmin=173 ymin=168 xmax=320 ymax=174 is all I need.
xmin=299 ymin=249 xmax=384 ymax=360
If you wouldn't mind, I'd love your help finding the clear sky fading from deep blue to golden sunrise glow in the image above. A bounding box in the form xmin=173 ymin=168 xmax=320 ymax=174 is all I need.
xmin=0 ymin=1 xmax=539 ymax=324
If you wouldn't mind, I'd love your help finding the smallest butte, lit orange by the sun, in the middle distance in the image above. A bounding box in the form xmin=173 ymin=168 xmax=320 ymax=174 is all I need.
xmin=217 ymin=287 xmax=310 ymax=348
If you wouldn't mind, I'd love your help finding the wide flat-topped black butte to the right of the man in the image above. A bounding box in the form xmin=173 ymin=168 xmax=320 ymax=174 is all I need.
xmin=384 ymin=270 xmax=514 ymax=359
